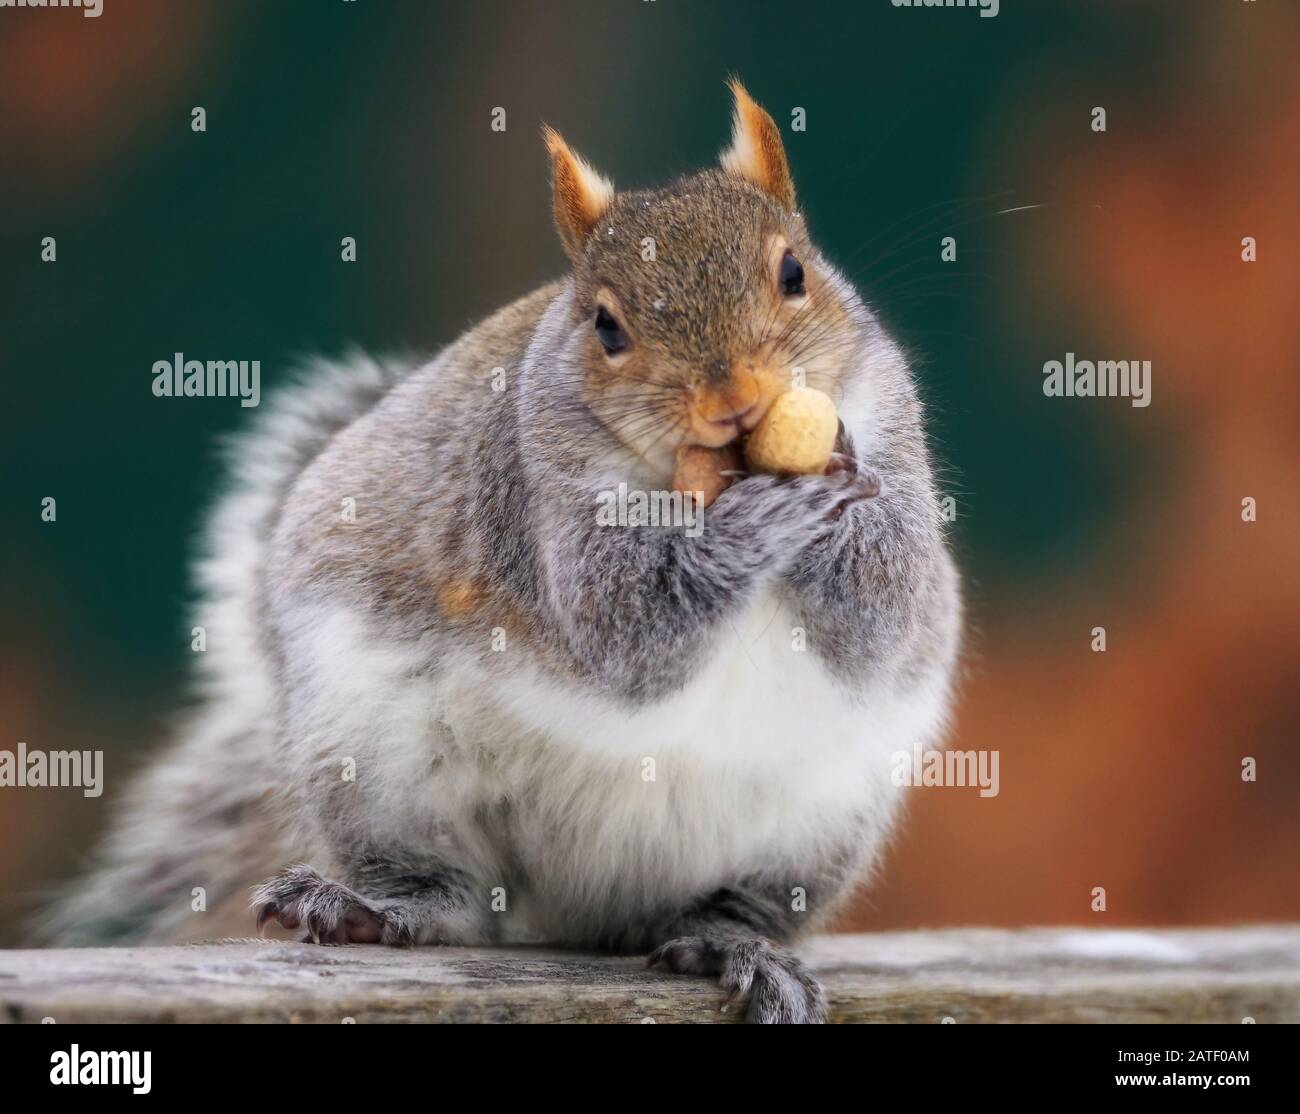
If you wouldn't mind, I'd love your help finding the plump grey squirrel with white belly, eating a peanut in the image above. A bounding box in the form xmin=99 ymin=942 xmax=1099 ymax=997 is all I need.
xmin=44 ymin=81 xmax=962 ymax=1022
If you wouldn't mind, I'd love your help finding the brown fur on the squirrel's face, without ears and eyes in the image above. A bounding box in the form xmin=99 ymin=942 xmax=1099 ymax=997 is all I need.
xmin=573 ymin=170 xmax=853 ymax=463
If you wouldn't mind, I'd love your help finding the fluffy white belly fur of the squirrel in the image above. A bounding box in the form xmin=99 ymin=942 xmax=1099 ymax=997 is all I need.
xmin=295 ymin=593 xmax=944 ymax=940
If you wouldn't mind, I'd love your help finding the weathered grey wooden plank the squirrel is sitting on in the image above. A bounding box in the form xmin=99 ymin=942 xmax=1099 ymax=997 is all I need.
xmin=0 ymin=926 xmax=1300 ymax=1024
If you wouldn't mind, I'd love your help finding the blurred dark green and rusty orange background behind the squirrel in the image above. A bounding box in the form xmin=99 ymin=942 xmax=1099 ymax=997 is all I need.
xmin=0 ymin=0 xmax=1300 ymax=944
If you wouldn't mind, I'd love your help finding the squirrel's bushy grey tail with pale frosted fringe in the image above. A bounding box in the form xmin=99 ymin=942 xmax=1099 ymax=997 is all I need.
xmin=33 ymin=356 xmax=412 ymax=946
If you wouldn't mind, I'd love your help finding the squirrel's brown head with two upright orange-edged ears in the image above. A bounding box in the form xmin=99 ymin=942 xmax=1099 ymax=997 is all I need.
xmin=545 ymin=81 xmax=865 ymax=470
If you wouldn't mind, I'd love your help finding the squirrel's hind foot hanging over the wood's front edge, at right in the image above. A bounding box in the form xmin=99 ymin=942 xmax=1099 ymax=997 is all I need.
xmin=646 ymin=936 xmax=827 ymax=1024
